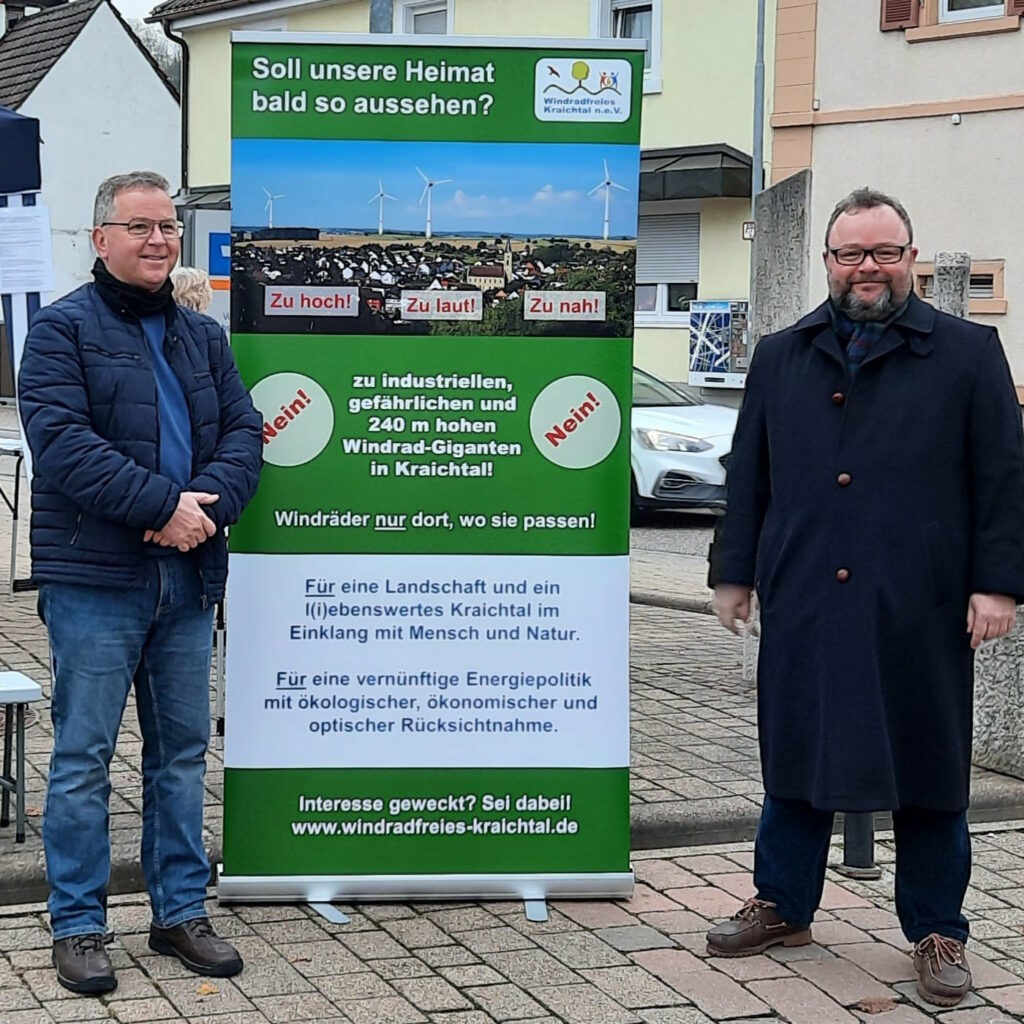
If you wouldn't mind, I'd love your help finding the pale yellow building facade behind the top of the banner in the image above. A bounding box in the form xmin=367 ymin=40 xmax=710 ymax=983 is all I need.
xmin=153 ymin=0 xmax=775 ymax=381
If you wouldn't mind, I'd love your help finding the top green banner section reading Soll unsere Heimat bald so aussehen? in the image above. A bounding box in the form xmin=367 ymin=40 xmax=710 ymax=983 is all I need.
xmin=231 ymin=36 xmax=643 ymax=145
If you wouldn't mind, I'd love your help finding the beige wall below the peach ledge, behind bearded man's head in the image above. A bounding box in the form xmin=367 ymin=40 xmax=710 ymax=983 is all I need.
xmin=810 ymin=109 xmax=1024 ymax=383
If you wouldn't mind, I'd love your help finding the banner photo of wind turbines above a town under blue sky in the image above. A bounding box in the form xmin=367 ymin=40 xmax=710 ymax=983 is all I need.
xmin=231 ymin=139 xmax=639 ymax=337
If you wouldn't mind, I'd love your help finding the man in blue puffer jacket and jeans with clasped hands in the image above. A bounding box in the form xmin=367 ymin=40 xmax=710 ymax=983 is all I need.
xmin=18 ymin=171 xmax=262 ymax=993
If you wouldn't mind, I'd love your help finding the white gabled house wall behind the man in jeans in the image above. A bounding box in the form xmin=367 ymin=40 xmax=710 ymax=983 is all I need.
xmin=18 ymin=4 xmax=181 ymax=303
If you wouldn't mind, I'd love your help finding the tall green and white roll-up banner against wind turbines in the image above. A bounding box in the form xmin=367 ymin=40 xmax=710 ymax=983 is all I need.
xmin=219 ymin=33 xmax=643 ymax=901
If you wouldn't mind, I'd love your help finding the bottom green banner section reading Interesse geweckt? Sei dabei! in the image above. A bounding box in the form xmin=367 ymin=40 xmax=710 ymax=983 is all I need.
xmin=224 ymin=768 xmax=630 ymax=874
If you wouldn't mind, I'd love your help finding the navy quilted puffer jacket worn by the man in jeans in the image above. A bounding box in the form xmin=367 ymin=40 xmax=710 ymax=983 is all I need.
xmin=17 ymin=284 xmax=262 ymax=602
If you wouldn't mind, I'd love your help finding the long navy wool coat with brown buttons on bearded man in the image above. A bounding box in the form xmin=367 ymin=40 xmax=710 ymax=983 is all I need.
xmin=710 ymin=297 xmax=1024 ymax=811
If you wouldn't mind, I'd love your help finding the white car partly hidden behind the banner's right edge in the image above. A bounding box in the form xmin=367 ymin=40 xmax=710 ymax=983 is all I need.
xmin=630 ymin=367 xmax=737 ymax=520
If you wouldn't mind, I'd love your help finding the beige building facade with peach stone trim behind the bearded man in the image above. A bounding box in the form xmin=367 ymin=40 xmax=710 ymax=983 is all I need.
xmin=771 ymin=0 xmax=1024 ymax=385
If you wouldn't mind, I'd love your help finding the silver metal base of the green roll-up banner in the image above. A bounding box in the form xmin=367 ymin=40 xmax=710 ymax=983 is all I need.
xmin=217 ymin=865 xmax=634 ymax=901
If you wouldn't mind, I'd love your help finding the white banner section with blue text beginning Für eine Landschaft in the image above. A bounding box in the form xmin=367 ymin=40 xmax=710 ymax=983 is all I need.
xmin=224 ymin=555 xmax=629 ymax=768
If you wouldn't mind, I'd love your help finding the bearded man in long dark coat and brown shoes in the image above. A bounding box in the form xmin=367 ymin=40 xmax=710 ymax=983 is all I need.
xmin=708 ymin=188 xmax=1024 ymax=1006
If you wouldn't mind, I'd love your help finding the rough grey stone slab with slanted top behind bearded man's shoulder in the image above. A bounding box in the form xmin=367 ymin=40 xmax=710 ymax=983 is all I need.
xmin=750 ymin=170 xmax=814 ymax=345
